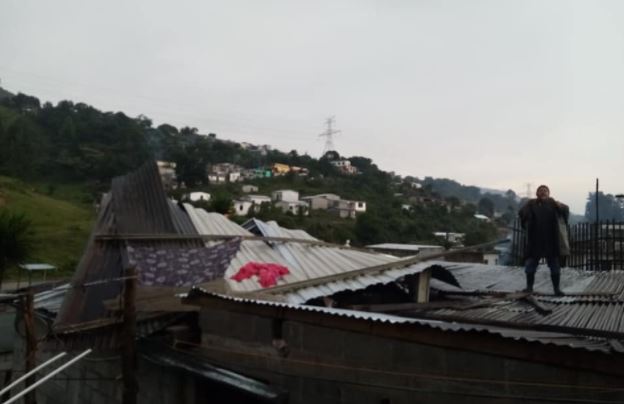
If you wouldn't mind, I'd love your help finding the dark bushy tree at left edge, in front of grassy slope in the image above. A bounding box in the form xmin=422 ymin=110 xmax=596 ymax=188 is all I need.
xmin=0 ymin=208 xmax=32 ymax=288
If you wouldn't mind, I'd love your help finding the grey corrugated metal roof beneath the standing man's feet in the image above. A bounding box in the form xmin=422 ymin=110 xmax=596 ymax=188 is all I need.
xmin=414 ymin=262 xmax=624 ymax=334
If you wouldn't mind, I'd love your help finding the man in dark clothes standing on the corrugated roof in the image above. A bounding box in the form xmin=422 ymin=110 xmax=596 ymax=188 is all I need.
xmin=519 ymin=185 xmax=570 ymax=296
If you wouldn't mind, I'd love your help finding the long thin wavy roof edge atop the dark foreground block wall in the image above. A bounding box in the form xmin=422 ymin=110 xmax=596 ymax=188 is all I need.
xmin=186 ymin=287 xmax=612 ymax=353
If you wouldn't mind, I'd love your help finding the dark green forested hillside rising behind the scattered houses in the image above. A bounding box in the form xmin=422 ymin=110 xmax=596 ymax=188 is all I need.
xmin=0 ymin=88 xmax=518 ymax=244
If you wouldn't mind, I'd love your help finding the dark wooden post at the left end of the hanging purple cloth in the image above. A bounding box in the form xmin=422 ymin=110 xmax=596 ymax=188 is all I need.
xmin=121 ymin=267 xmax=139 ymax=404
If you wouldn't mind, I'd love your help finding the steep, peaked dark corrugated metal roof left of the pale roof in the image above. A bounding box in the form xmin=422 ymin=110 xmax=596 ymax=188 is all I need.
xmin=54 ymin=162 xmax=203 ymax=327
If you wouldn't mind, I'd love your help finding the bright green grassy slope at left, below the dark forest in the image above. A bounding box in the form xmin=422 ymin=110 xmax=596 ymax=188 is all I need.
xmin=0 ymin=176 xmax=95 ymax=278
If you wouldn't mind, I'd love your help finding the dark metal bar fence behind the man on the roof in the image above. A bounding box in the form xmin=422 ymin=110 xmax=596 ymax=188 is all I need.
xmin=511 ymin=220 xmax=624 ymax=271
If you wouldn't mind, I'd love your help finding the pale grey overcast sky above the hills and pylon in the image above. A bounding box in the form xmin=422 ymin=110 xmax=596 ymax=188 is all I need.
xmin=0 ymin=0 xmax=624 ymax=213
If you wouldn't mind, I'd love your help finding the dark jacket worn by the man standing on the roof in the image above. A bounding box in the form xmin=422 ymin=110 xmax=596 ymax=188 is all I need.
xmin=518 ymin=198 xmax=570 ymax=259
